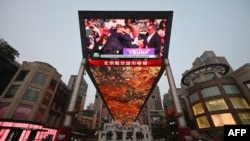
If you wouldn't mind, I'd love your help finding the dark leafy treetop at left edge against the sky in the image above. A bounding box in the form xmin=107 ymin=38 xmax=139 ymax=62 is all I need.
xmin=0 ymin=38 xmax=19 ymax=61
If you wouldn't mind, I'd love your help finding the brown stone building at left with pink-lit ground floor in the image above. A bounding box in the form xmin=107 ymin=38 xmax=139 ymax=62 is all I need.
xmin=0 ymin=61 xmax=71 ymax=140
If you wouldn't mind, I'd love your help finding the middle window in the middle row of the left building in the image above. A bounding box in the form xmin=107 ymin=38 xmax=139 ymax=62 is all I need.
xmin=22 ymin=87 xmax=40 ymax=101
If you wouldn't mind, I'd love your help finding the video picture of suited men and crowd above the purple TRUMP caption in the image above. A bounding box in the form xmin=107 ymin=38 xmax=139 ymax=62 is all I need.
xmin=85 ymin=19 xmax=167 ymax=57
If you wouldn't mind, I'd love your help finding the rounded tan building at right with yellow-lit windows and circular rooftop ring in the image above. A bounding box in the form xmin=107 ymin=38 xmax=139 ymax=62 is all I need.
xmin=181 ymin=51 xmax=250 ymax=141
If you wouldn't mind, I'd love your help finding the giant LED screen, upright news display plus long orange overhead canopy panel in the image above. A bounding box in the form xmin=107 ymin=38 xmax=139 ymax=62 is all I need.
xmin=79 ymin=11 xmax=173 ymax=123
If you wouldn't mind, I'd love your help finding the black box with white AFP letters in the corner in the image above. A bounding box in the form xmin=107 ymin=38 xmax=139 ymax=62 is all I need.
xmin=224 ymin=124 xmax=250 ymax=141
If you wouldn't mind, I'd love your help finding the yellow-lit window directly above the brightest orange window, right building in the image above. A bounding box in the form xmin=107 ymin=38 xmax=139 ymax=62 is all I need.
xmin=206 ymin=98 xmax=228 ymax=112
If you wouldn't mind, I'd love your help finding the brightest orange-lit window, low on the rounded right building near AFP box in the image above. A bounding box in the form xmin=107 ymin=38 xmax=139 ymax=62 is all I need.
xmin=211 ymin=113 xmax=236 ymax=127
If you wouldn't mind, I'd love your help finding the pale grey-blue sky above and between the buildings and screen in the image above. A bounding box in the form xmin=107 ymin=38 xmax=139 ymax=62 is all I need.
xmin=0 ymin=0 xmax=250 ymax=107
